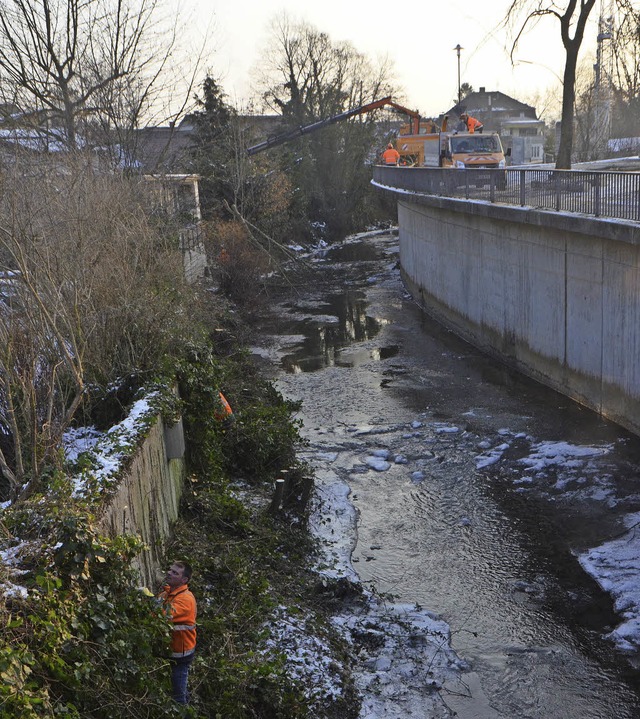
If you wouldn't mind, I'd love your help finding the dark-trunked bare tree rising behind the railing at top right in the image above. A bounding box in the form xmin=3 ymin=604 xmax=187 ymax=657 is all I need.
xmin=505 ymin=0 xmax=595 ymax=169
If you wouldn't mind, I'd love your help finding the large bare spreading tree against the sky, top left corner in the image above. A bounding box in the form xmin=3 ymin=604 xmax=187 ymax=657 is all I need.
xmin=0 ymin=0 xmax=182 ymax=148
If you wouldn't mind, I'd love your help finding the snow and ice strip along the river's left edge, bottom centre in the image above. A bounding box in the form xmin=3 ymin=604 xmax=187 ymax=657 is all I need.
xmin=309 ymin=464 xmax=467 ymax=719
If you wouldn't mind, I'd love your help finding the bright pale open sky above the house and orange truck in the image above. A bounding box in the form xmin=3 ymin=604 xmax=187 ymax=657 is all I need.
xmin=185 ymin=0 xmax=598 ymax=116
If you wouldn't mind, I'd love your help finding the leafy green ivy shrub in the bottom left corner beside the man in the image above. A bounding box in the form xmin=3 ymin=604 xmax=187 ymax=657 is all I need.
xmin=0 ymin=507 xmax=175 ymax=719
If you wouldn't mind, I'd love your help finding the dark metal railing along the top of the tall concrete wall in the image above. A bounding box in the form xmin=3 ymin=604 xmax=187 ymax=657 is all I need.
xmin=373 ymin=165 xmax=640 ymax=222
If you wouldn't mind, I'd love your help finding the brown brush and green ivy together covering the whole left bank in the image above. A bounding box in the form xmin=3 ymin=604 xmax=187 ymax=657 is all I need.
xmin=0 ymin=118 xmax=372 ymax=719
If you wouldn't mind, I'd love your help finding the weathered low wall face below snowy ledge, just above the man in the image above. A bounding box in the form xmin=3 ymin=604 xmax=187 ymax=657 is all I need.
xmin=100 ymin=417 xmax=185 ymax=590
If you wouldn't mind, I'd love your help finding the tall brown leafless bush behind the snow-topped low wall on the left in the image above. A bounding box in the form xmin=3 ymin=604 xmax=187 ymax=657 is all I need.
xmin=0 ymin=150 xmax=202 ymax=495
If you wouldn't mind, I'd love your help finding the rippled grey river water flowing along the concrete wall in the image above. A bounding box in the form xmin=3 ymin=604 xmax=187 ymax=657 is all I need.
xmin=258 ymin=235 xmax=640 ymax=719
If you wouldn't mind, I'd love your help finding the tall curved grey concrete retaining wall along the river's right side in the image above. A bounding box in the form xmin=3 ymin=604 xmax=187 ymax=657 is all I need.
xmin=398 ymin=194 xmax=640 ymax=433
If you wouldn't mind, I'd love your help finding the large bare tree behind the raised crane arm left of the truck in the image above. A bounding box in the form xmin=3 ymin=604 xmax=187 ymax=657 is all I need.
xmin=250 ymin=15 xmax=392 ymax=235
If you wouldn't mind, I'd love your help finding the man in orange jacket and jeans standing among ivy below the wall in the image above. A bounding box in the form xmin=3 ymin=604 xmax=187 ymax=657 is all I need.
xmin=159 ymin=562 xmax=197 ymax=704
